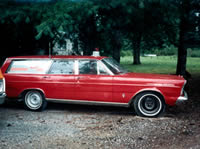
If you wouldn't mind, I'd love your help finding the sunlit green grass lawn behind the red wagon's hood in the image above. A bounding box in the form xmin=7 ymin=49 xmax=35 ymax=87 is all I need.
xmin=121 ymin=56 xmax=200 ymax=75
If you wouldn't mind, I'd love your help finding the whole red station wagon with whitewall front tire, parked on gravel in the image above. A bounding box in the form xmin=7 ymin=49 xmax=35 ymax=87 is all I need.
xmin=2 ymin=56 xmax=187 ymax=117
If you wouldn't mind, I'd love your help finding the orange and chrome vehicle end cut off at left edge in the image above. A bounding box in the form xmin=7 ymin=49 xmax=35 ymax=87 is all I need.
xmin=0 ymin=69 xmax=6 ymax=104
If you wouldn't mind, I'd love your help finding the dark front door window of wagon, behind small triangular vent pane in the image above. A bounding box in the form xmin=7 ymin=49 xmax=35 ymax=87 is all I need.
xmin=79 ymin=60 xmax=97 ymax=74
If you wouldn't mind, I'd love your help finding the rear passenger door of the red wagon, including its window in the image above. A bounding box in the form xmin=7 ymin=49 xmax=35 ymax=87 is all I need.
xmin=44 ymin=59 xmax=75 ymax=100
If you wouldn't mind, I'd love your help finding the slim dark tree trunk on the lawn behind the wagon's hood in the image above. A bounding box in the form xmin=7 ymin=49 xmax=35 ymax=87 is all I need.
xmin=133 ymin=34 xmax=142 ymax=65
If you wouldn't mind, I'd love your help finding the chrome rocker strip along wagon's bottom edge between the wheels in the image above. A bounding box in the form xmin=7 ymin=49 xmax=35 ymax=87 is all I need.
xmin=46 ymin=98 xmax=129 ymax=107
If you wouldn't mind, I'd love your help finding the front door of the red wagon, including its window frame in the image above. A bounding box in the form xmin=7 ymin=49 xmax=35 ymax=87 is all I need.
xmin=75 ymin=59 xmax=112 ymax=102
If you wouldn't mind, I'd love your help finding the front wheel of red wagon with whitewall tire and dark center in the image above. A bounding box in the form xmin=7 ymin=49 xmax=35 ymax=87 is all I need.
xmin=133 ymin=92 xmax=165 ymax=117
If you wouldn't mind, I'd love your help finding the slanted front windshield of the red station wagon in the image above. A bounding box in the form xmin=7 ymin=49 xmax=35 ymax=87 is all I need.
xmin=102 ymin=58 xmax=127 ymax=74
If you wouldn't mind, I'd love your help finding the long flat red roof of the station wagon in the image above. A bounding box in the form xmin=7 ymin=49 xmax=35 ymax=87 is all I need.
xmin=9 ymin=55 xmax=107 ymax=60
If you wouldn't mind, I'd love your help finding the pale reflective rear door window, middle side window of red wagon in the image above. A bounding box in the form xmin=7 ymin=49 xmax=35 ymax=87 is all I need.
xmin=49 ymin=60 xmax=74 ymax=74
